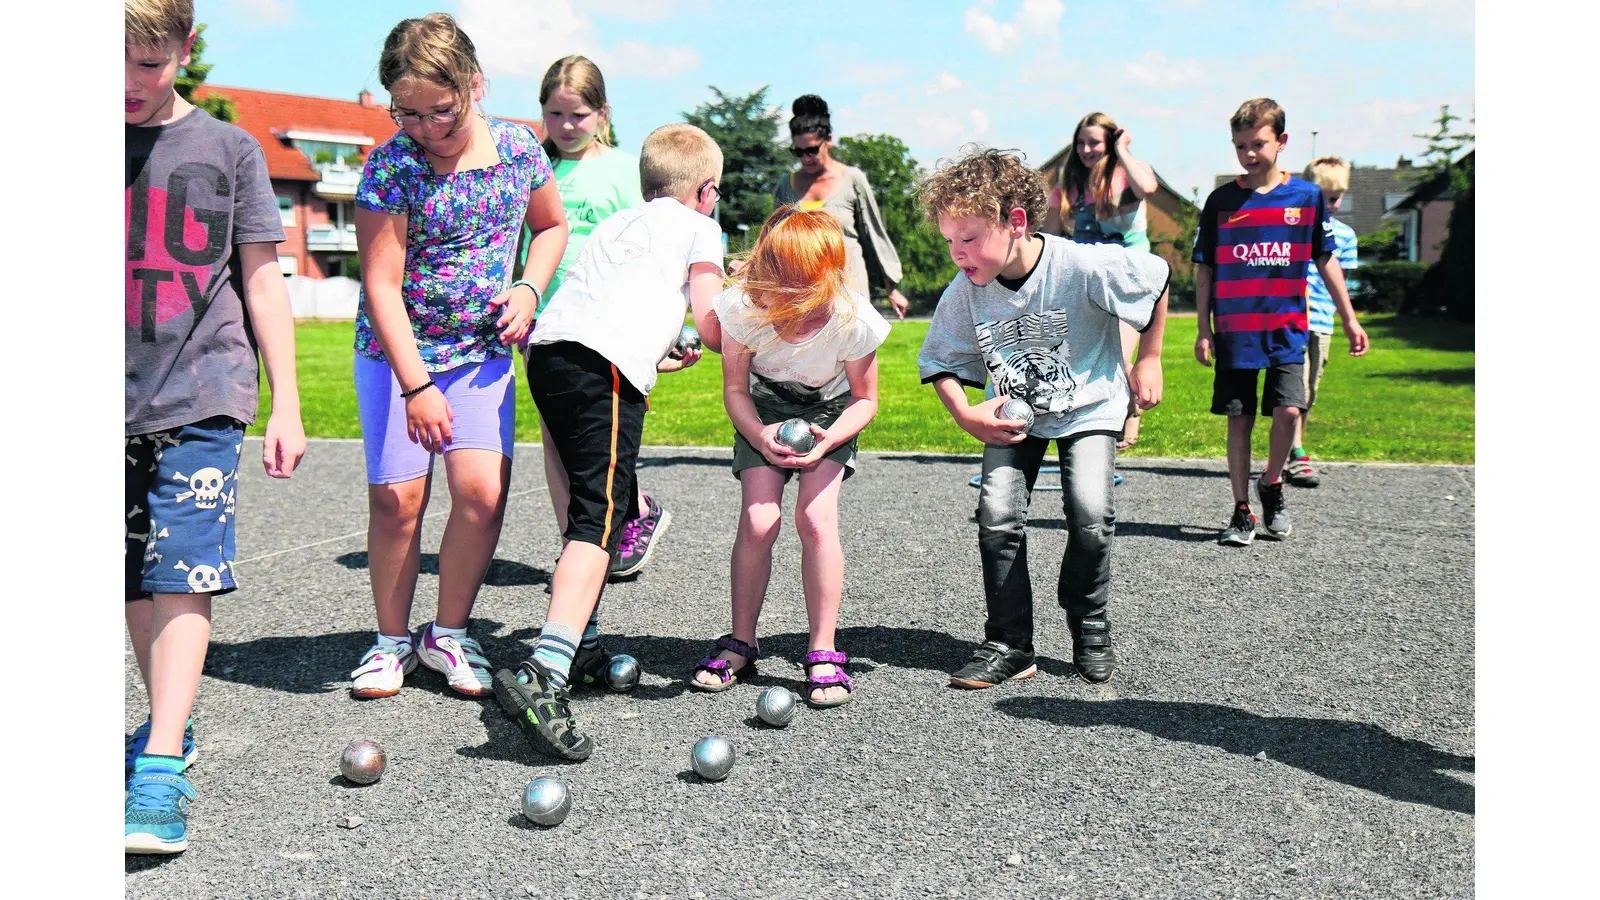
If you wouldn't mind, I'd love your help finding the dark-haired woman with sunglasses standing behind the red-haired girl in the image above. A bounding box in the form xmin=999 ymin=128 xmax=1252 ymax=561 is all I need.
xmin=773 ymin=94 xmax=910 ymax=319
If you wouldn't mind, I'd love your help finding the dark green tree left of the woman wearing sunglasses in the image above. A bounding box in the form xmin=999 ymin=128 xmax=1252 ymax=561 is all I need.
xmin=683 ymin=86 xmax=789 ymax=250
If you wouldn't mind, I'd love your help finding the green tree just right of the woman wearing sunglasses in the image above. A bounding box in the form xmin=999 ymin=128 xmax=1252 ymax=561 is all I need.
xmin=834 ymin=135 xmax=955 ymax=311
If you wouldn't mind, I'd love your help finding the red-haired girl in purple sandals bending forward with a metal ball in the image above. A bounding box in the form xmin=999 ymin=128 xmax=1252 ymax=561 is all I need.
xmin=690 ymin=207 xmax=890 ymax=708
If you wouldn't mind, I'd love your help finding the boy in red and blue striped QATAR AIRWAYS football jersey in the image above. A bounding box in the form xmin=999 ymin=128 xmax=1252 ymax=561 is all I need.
xmin=1194 ymin=98 xmax=1368 ymax=546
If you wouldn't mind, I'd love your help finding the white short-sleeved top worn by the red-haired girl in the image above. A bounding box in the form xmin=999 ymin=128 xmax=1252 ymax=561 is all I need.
xmin=715 ymin=288 xmax=890 ymax=402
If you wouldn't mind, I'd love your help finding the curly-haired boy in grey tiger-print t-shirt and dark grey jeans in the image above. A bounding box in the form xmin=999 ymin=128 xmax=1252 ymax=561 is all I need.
xmin=917 ymin=151 xmax=1171 ymax=689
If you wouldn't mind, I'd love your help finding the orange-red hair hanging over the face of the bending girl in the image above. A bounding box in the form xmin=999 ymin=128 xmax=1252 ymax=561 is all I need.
xmin=733 ymin=207 xmax=856 ymax=340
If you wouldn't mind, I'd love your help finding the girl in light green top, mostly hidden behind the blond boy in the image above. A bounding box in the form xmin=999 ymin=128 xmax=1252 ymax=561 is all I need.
xmin=534 ymin=56 xmax=672 ymax=637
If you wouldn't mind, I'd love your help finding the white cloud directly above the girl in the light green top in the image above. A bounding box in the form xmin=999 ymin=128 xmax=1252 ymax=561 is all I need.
xmin=456 ymin=0 xmax=701 ymax=80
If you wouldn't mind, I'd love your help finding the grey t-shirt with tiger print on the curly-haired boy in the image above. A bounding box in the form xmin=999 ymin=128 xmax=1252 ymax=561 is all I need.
xmin=917 ymin=234 xmax=1171 ymax=437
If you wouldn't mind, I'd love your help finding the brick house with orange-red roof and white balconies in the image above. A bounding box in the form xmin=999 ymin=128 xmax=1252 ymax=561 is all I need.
xmin=197 ymin=85 xmax=544 ymax=279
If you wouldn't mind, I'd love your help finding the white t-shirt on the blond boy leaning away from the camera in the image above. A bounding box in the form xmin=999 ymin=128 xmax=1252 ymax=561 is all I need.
xmin=528 ymin=197 xmax=722 ymax=394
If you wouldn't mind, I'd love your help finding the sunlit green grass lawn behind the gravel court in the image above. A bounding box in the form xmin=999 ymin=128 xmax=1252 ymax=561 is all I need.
xmin=251 ymin=315 xmax=1474 ymax=463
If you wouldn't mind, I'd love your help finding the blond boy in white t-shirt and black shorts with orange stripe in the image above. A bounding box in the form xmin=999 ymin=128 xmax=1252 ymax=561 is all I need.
xmin=494 ymin=123 xmax=723 ymax=761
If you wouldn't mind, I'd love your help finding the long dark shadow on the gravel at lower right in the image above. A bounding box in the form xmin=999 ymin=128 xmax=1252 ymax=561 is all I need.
xmin=995 ymin=697 xmax=1477 ymax=815
